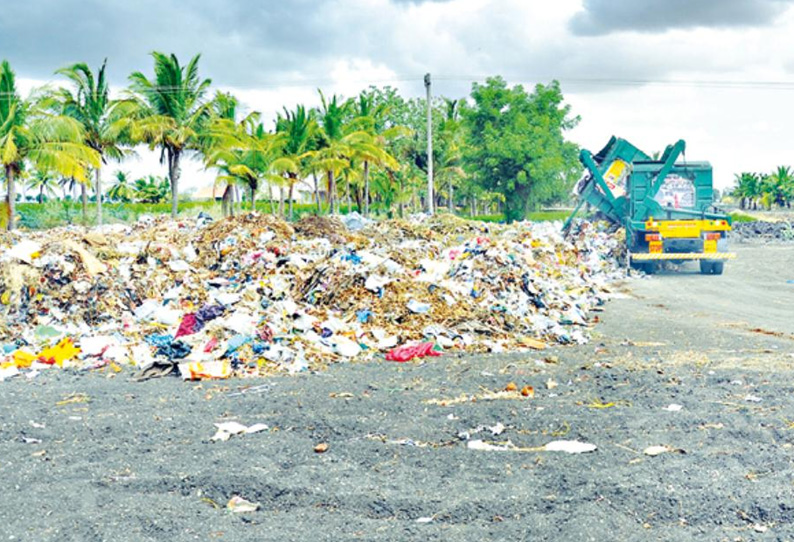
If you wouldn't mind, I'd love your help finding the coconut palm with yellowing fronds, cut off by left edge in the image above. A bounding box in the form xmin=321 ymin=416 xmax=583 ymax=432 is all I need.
xmin=0 ymin=60 xmax=100 ymax=230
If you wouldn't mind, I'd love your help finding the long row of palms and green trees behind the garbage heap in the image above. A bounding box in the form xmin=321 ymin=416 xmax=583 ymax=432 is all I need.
xmin=0 ymin=52 xmax=580 ymax=229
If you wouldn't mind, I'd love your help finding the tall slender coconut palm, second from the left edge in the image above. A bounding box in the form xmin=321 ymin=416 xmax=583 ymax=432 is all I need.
xmin=56 ymin=59 xmax=124 ymax=225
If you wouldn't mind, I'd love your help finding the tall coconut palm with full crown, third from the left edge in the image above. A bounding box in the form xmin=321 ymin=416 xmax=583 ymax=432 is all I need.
xmin=124 ymin=51 xmax=211 ymax=218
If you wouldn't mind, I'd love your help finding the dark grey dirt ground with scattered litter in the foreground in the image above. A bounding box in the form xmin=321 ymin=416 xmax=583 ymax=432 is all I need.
xmin=0 ymin=247 xmax=794 ymax=542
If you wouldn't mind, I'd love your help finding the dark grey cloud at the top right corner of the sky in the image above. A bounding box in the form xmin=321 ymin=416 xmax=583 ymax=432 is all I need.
xmin=570 ymin=0 xmax=792 ymax=36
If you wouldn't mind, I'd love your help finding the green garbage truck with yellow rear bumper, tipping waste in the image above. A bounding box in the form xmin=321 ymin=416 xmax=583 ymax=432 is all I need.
xmin=563 ymin=136 xmax=736 ymax=275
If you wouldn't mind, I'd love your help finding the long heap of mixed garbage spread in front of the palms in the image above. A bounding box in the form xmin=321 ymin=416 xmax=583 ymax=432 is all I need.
xmin=0 ymin=213 xmax=624 ymax=380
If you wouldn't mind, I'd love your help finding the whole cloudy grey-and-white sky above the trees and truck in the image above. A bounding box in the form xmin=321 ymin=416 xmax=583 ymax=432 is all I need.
xmin=0 ymin=0 xmax=794 ymax=191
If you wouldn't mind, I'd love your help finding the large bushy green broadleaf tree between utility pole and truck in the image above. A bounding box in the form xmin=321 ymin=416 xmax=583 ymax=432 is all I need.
xmin=463 ymin=77 xmax=580 ymax=222
